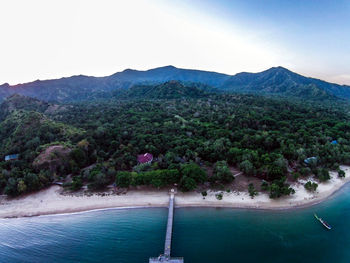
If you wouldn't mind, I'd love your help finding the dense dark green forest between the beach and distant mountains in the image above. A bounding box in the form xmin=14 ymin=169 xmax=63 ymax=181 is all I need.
xmin=0 ymin=91 xmax=350 ymax=197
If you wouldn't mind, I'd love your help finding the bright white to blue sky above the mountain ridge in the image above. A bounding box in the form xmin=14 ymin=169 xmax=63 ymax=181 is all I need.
xmin=0 ymin=0 xmax=350 ymax=85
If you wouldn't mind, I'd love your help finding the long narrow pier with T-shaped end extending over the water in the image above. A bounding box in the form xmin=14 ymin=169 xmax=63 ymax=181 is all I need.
xmin=149 ymin=189 xmax=184 ymax=263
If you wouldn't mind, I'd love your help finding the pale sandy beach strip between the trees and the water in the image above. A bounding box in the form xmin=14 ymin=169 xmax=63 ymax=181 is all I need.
xmin=0 ymin=166 xmax=350 ymax=218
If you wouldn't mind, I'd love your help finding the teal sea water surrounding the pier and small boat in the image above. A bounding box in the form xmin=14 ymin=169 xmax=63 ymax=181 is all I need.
xmin=0 ymin=185 xmax=350 ymax=263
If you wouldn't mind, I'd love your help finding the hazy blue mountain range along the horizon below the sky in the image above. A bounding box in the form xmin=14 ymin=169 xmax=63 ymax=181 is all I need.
xmin=0 ymin=66 xmax=350 ymax=102
